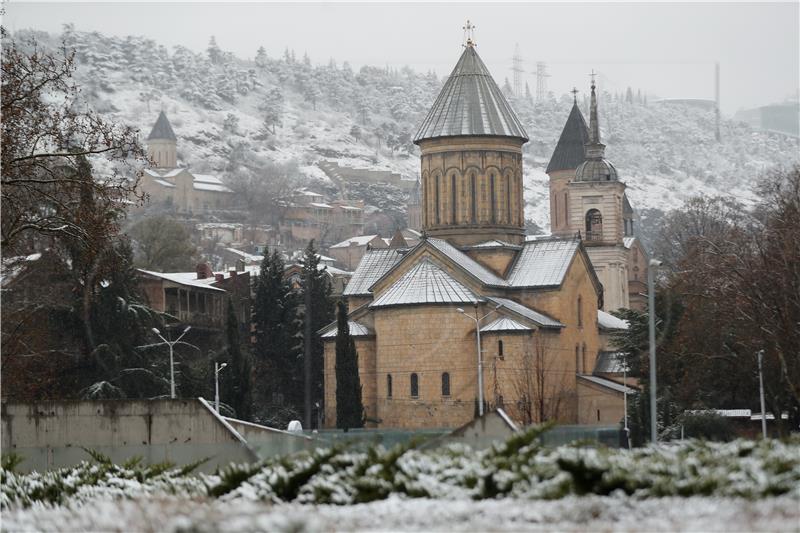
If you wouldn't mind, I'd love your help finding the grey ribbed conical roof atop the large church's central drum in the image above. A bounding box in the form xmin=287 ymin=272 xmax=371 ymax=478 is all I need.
xmin=414 ymin=45 xmax=528 ymax=143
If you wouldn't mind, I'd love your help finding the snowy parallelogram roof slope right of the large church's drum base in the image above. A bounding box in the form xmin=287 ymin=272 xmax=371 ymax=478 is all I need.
xmin=508 ymin=239 xmax=578 ymax=287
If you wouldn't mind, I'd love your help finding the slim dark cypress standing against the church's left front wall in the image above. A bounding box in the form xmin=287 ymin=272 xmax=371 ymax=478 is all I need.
xmin=336 ymin=300 xmax=364 ymax=430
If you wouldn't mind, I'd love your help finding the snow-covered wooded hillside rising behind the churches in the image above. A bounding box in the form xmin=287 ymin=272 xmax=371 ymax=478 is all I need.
xmin=16 ymin=27 xmax=799 ymax=237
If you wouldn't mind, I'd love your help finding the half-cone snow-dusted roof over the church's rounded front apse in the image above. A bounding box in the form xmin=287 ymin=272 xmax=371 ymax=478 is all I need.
xmin=370 ymin=257 xmax=481 ymax=307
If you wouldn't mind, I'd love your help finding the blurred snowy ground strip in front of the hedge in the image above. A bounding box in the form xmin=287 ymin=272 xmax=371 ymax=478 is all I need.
xmin=2 ymin=496 xmax=800 ymax=532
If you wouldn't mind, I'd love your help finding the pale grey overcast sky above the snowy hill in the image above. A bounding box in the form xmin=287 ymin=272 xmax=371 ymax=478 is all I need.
xmin=3 ymin=0 xmax=800 ymax=114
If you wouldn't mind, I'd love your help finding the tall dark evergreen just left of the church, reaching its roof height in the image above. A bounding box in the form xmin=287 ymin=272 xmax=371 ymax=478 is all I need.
xmin=300 ymin=240 xmax=334 ymax=428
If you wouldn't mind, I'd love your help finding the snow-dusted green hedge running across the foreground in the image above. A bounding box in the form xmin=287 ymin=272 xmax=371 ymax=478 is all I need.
xmin=0 ymin=430 xmax=800 ymax=509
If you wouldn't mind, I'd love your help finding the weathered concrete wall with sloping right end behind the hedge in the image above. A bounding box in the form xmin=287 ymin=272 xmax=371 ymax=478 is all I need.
xmin=2 ymin=399 xmax=257 ymax=472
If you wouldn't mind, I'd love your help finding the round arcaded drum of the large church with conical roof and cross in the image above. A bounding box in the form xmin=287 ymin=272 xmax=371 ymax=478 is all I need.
xmin=414 ymin=21 xmax=528 ymax=246
